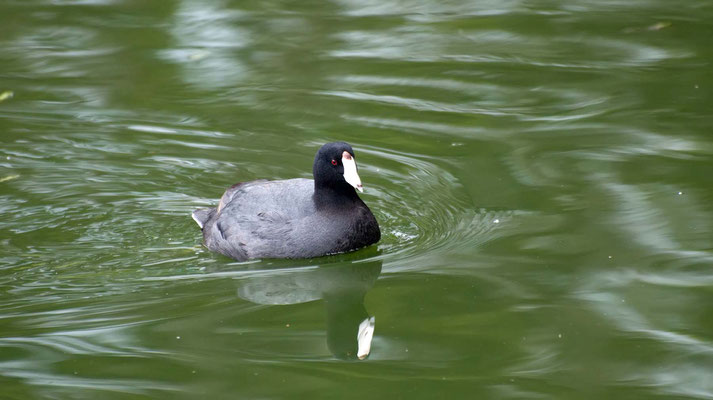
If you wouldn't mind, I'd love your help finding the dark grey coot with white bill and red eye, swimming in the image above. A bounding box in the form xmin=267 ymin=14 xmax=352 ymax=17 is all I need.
xmin=193 ymin=142 xmax=381 ymax=260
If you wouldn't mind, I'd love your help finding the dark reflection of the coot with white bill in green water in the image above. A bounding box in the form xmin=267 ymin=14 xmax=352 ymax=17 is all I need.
xmin=238 ymin=261 xmax=381 ymax=360
